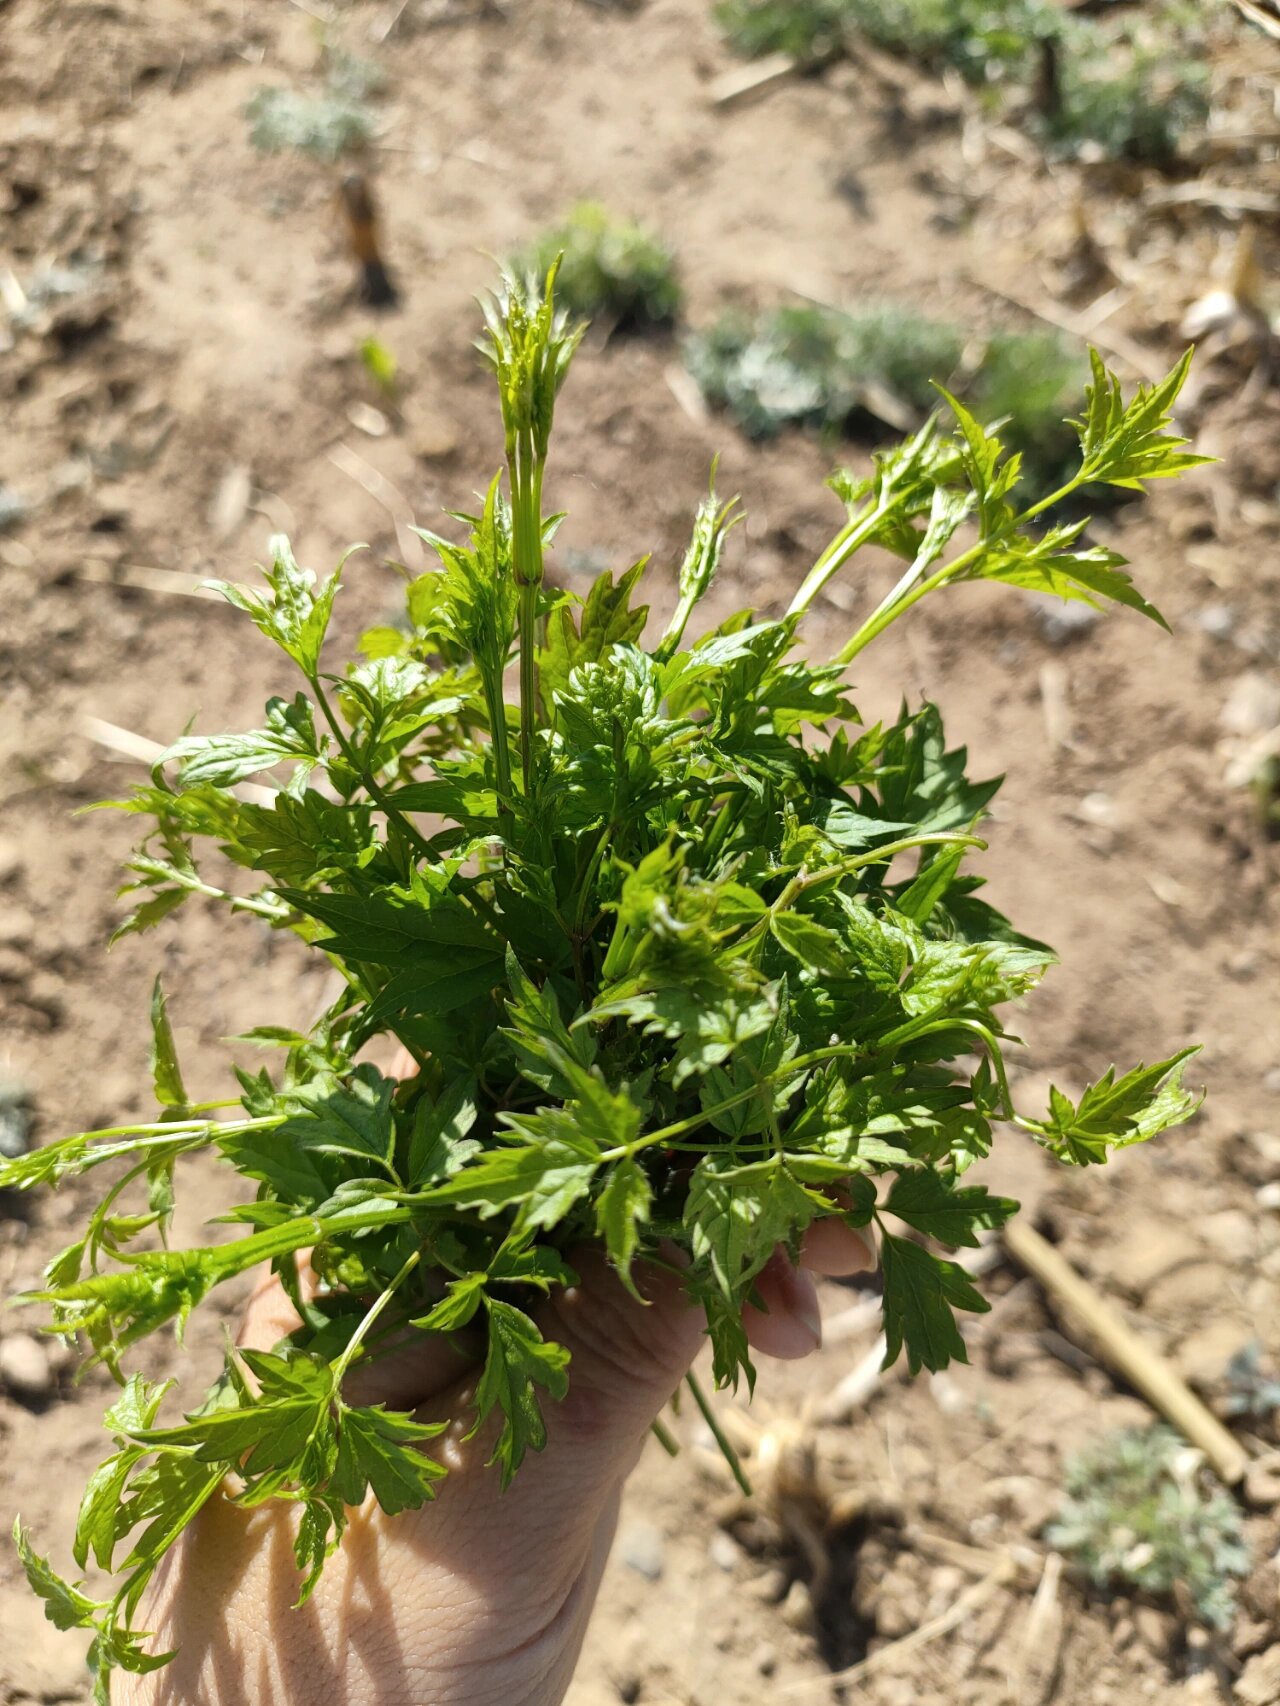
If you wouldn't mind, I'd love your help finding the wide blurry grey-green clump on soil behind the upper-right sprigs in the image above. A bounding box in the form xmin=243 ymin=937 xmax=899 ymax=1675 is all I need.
xmin=684 ymin=304 xmax=1084 ymax=491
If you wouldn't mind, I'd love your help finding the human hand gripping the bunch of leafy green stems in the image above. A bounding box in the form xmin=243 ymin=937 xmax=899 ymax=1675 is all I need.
xmin=116 ymin=1220 xmax=872 ymax=1706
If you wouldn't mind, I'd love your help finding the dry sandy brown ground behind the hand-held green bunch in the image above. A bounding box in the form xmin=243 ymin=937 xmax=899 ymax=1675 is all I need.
xmin=0 ymin=0 xmax=1280 ymax=1706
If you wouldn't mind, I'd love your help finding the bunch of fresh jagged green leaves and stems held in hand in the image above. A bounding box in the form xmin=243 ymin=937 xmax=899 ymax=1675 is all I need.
xmin=0 ymin=270 xmax=1200 ymax=1701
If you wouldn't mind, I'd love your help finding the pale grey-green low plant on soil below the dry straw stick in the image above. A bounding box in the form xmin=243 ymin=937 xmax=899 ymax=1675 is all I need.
xmin=1046 ymin=1426 xmax=1251 ymax=1629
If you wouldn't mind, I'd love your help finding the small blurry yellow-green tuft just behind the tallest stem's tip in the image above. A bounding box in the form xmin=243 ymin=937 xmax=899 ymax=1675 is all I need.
xmin=510 ymin=201 xmax=684 ymax=329
